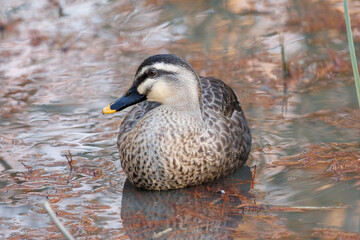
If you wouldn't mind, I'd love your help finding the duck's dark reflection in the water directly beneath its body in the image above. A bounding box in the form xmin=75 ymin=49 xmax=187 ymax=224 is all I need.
xmin=121 ymin=166 xmax=252 ymax=239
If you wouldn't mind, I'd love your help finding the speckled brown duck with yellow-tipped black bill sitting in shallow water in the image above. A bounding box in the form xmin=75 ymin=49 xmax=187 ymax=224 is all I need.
xmin=102 ymin=54 xmax=251 ymax=191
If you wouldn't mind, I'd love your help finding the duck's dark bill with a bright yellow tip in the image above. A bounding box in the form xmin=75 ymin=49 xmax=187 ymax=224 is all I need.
xmin=103 ymin=84 xmax=146 ymax=114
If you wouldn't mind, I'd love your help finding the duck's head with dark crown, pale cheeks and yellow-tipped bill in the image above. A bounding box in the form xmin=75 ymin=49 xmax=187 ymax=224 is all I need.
xmin=102 ymin=54 xmax=201 ymax=114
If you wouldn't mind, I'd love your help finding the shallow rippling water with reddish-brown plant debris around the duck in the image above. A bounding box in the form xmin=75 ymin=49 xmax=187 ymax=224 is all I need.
xmin=0 ymin=0 xmax=360 ymax=239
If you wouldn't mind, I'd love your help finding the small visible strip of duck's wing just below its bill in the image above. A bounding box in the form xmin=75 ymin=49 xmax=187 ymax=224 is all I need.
xmin=119 ymin=101 xmax=160 ymax=136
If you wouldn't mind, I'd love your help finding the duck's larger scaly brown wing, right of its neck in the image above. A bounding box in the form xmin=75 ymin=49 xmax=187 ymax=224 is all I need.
xmin=200 ymin=77 xmax=251 ymax=161
